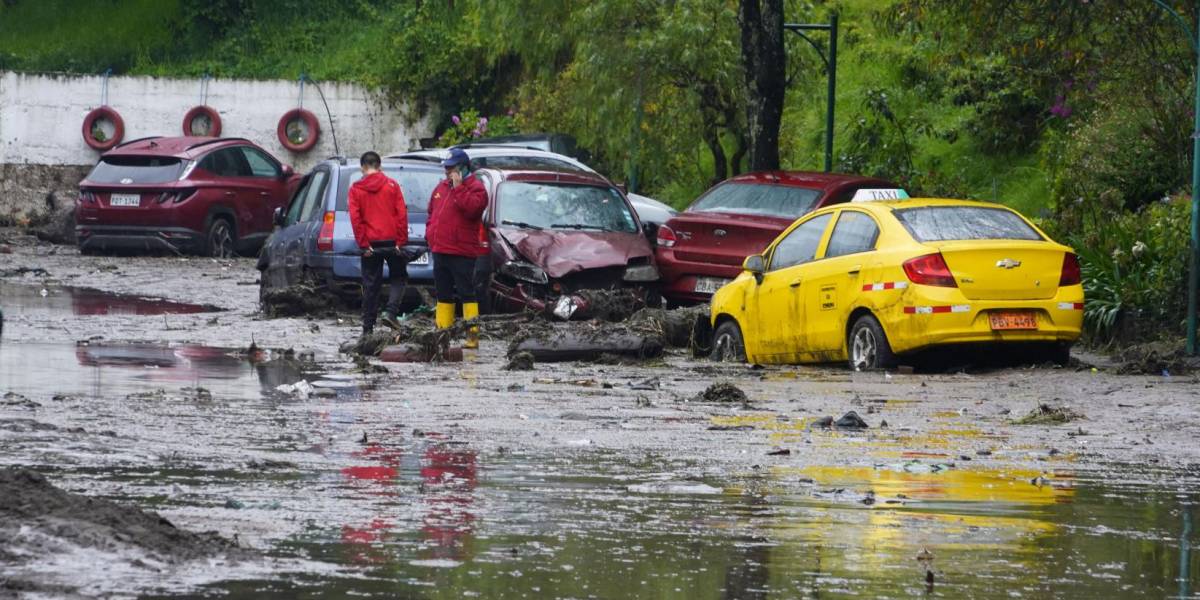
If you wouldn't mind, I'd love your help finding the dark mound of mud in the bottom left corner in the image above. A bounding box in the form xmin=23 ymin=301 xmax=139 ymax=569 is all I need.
xmin=0 ymin=468 xmax=254 ymax=589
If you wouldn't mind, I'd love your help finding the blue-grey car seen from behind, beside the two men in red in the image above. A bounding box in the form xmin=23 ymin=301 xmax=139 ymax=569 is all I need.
xmin=258 ymin=157 xmax=445 ymax=302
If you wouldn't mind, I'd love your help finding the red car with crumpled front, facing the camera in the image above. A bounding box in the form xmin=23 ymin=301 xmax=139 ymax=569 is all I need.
xmin=475 ymin=168 xmax=659 ymax=319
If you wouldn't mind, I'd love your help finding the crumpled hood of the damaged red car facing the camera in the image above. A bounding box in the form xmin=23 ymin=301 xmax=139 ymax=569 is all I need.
xmin=499 ymin=229 xmax=650 ymax=278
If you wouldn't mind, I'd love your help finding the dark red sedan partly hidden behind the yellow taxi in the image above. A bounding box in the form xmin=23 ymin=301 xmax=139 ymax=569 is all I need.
xmin=656 ymin=170 xmax=895 ymax=305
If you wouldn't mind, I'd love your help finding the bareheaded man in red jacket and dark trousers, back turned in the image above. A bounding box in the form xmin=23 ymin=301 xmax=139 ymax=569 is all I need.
xmin=350 ymin=152 xmax=408 ymax=335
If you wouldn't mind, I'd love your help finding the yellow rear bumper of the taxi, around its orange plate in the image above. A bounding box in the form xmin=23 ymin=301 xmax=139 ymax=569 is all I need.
xmin=881 ymin=286 xmax=1084 ymax=354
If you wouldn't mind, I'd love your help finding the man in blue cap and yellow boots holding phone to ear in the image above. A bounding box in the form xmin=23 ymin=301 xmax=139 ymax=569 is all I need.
xmin=425 ymin=148 xmax=488 ymax=348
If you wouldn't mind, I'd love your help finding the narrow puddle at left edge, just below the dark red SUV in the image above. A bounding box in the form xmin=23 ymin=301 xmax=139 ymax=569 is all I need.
xmin=0 ymin=282 xmax=222 ymax=318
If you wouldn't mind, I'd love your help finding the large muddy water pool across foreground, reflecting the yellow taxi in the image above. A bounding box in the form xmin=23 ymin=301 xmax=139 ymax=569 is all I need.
xmin=0 ymin=343 xmax=1200 ymax=599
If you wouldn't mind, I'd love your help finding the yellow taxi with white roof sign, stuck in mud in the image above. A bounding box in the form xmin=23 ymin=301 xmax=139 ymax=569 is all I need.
xmin=712 ymin=192 xmax=1084 ymax=370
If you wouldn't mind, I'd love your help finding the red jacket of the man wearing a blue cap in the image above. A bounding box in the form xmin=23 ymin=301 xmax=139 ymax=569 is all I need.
xmin=425 ymin=175 xmax=488 ymax=257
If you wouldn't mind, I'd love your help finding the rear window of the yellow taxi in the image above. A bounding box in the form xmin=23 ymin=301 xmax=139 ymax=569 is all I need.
xmin=894 ymin=206 xmax=1042 ymax=241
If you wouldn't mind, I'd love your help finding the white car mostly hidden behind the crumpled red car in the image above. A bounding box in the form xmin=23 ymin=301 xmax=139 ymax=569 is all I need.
xmin=390 ymin=142 xmax=677 ymax=226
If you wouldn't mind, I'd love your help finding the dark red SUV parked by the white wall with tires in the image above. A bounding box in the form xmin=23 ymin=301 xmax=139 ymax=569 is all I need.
xmin=76 ymin=137 xmax=300 ymax=257
